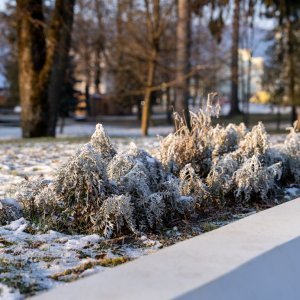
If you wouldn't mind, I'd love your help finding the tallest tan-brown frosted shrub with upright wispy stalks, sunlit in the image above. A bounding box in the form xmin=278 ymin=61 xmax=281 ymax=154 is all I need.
xmin=158 ymin=95 xmax=247 ymax=177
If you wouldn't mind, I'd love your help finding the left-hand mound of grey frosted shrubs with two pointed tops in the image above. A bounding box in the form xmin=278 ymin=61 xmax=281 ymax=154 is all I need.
xmin=17 ymin=126 xmax=188 ymax=236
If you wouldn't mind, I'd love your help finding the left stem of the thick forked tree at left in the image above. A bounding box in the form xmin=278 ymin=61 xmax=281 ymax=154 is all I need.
xmin=17 ymin=0 xmax=48 ymax=138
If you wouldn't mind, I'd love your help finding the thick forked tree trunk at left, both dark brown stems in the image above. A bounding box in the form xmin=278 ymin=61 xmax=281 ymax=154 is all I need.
xmin=17 ymin=0 xmax=75 ymax=137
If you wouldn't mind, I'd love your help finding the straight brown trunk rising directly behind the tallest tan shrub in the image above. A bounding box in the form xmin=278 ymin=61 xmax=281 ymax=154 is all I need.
xmin=175 ymin=0 xmax=190 ymax=128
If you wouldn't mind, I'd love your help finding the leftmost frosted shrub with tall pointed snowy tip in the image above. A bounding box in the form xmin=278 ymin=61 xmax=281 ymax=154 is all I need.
xmin=17 ymin=126 xmax=118 ymax=232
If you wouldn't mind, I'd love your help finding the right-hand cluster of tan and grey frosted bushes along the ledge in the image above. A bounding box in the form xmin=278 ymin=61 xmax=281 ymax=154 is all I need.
xmin=158 ymin=95 xmax=300 ymax=209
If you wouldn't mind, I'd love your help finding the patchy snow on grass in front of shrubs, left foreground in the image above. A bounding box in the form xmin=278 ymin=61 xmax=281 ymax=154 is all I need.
xmin=0 ymin=218 xmax=161 ymax=299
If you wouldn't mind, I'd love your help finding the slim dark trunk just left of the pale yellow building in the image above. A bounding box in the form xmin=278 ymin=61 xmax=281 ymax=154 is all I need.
xmin=230 ymin=0 xmax=240 ymax=115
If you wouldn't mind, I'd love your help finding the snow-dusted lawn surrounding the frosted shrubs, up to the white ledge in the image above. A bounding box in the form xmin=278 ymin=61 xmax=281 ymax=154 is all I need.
xmin=0 ymin=136 xmax=300 ymax=299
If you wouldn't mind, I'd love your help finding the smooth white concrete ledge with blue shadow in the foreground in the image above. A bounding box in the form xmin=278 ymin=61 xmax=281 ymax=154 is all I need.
xmin=34 ymin=198 xmax=300 ymax=300
